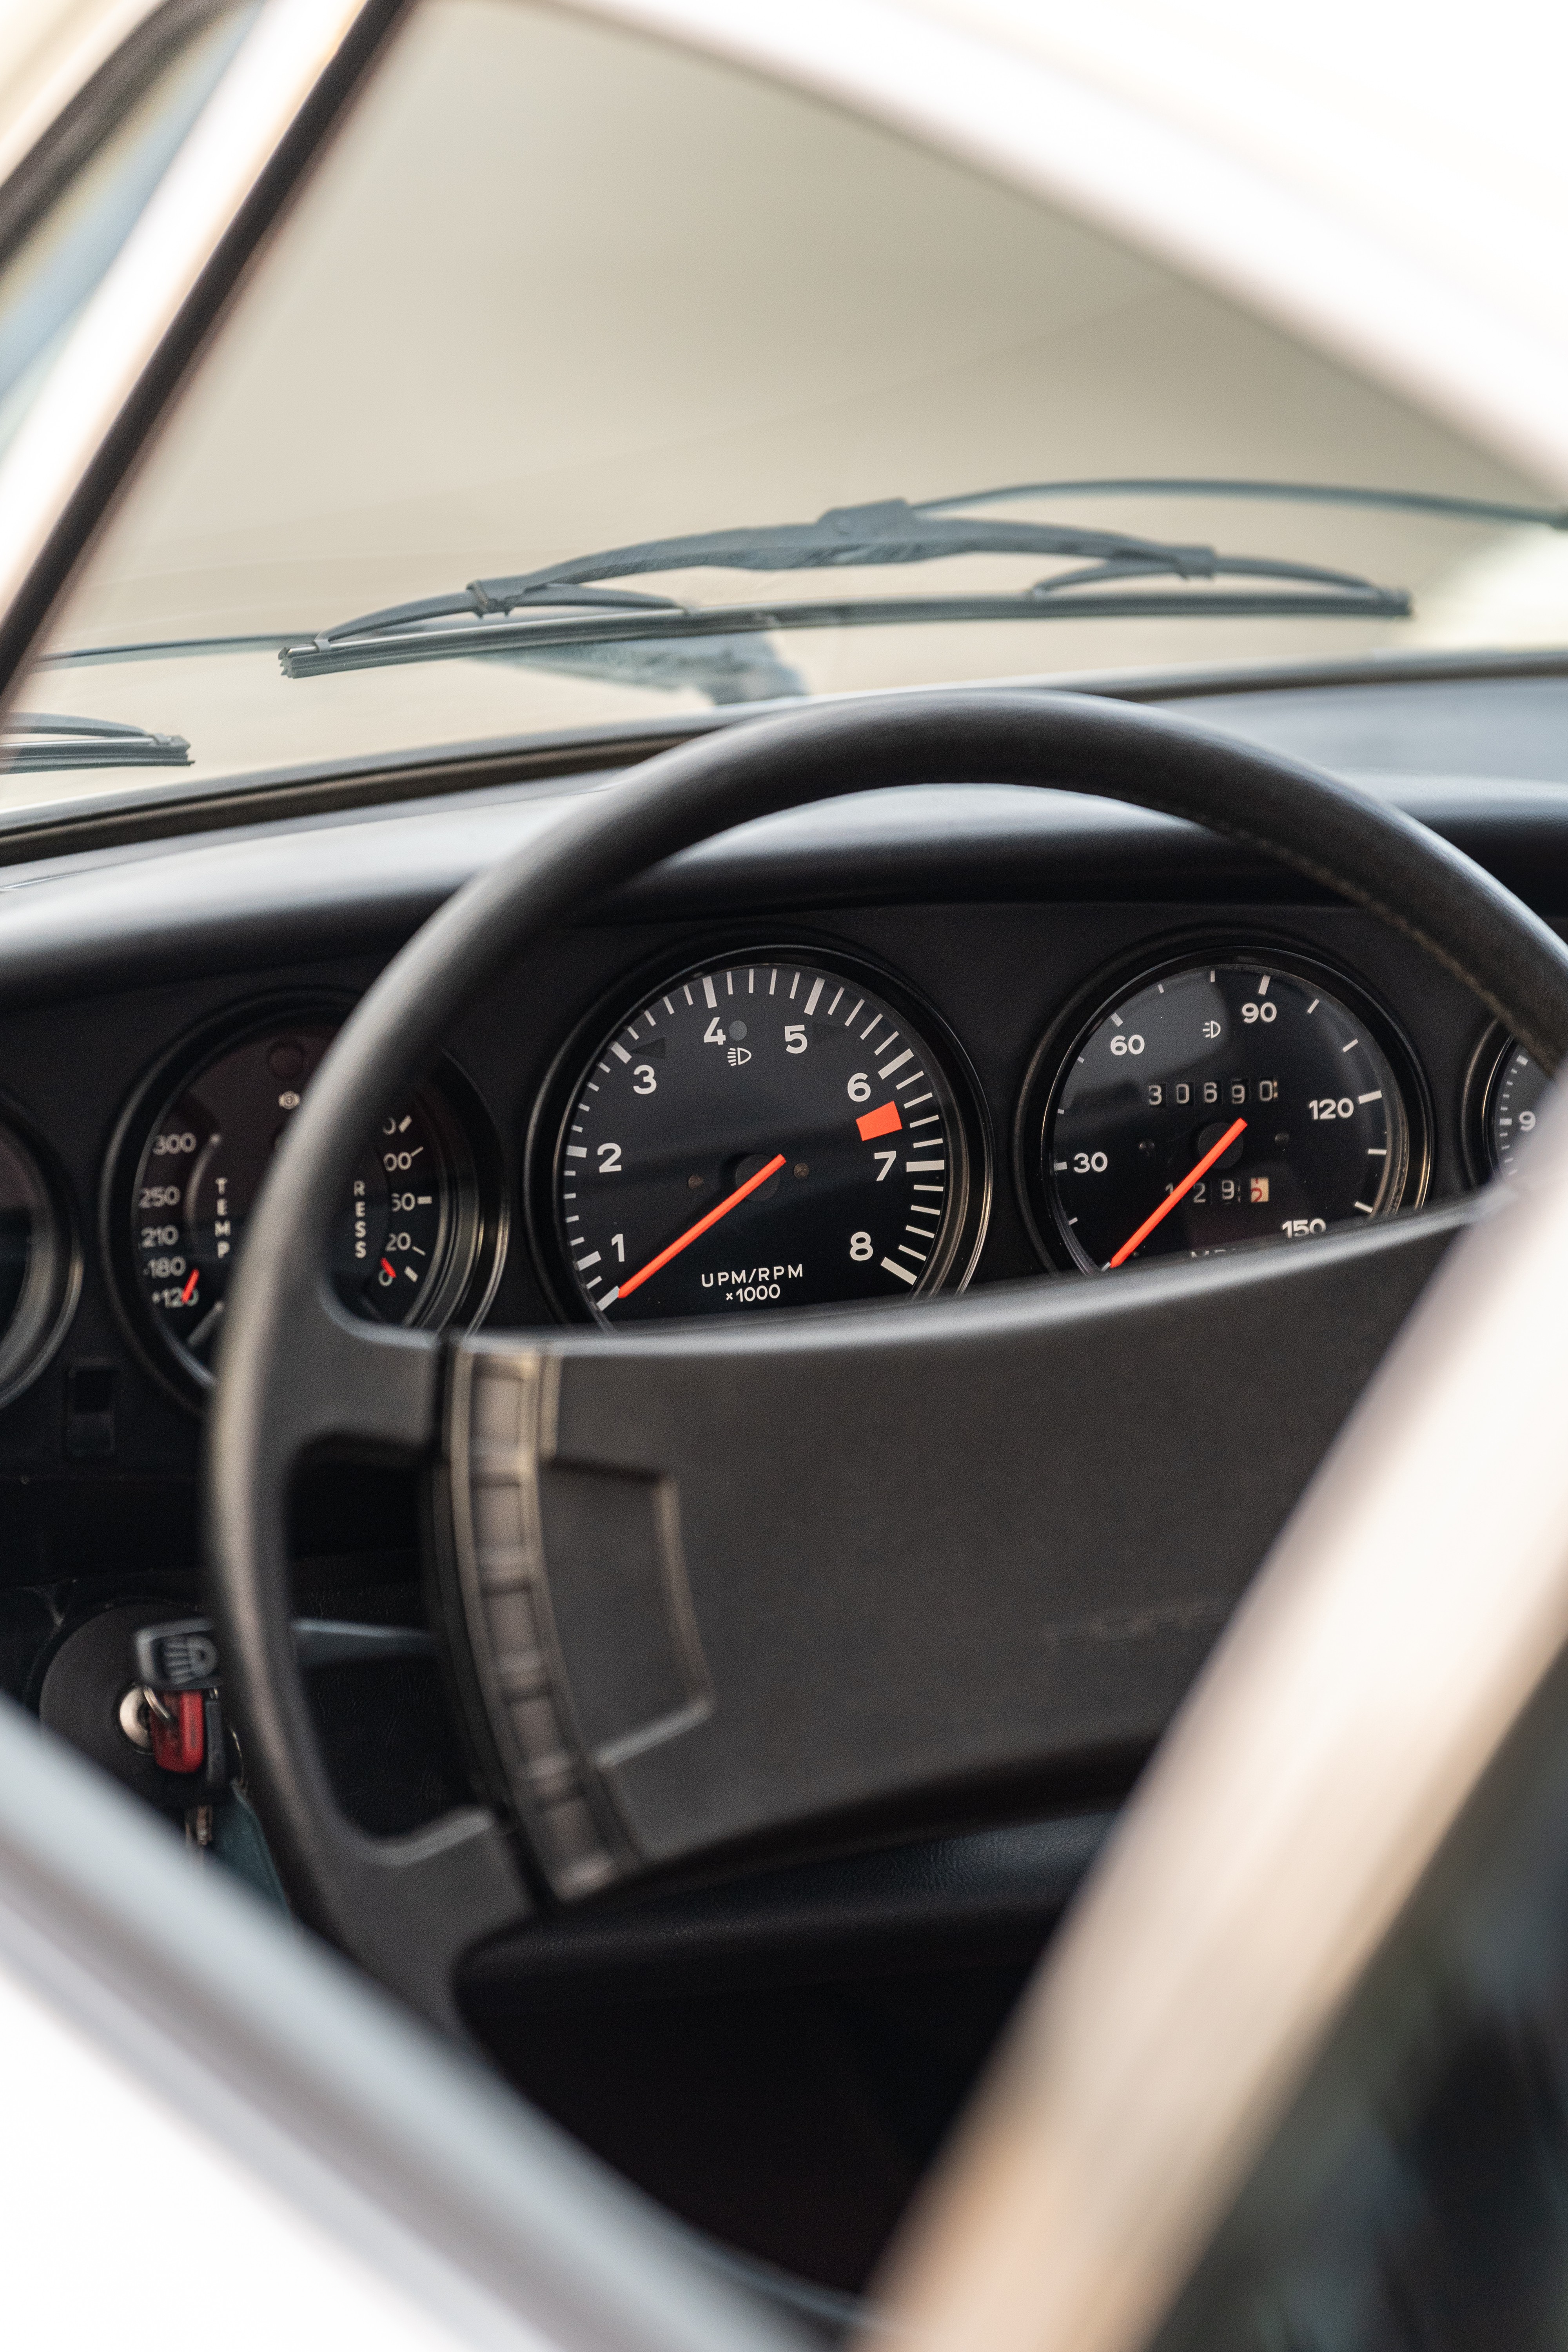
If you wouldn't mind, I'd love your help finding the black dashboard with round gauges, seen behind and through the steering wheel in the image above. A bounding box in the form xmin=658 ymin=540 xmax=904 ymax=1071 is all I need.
xmin=0 ymin=696 xmax=1568 ymax=1583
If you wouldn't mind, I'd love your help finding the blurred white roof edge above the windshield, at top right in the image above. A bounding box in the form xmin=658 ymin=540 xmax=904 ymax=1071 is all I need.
xmin=566 ymin=0 xmax=1568 ymax=494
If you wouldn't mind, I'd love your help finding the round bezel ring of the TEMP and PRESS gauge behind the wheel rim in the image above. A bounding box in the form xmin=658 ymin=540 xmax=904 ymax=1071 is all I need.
xmin=99 ymin=993 xmax=510 ymax=1406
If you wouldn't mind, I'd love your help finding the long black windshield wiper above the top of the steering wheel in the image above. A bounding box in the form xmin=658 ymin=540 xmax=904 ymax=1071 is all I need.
xmin=278 ymin=499 xmax=1410 ymax=677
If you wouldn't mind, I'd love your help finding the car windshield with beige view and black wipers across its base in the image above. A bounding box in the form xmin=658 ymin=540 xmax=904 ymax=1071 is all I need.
xmin=0 ymin=0 xmax=1568 ymax=811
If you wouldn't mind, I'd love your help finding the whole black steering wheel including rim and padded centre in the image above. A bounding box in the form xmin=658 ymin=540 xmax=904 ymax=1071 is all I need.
xmin=205 ymin=691 xmax=1568 ymax=2025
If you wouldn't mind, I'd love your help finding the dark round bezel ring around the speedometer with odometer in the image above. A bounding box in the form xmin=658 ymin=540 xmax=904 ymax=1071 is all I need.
xmin=1013 ymin=931 xmax=1432 ymax=1275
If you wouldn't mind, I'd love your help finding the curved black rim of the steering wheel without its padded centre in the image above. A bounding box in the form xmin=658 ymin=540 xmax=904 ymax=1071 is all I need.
xmin=205 ymin=689 xmax=1568 ymax=2020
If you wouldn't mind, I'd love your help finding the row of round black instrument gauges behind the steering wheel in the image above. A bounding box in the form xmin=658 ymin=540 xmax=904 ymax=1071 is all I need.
xmin=0 ymin=934 xmax=1547 ymax=1404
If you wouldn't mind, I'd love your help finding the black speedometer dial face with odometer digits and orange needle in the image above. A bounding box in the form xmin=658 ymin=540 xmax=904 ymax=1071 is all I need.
xmin=1034 ymin=960 xmax=1410 ymax=1268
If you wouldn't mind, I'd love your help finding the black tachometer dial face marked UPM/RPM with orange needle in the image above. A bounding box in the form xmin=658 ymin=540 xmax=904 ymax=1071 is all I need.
xmin=555 ymin=953 xmax=969 ymax=1324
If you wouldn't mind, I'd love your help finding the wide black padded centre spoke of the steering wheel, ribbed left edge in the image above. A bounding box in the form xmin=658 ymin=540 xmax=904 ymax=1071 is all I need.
xmin=449 ymin=1211 xmax=1467 ymax=1898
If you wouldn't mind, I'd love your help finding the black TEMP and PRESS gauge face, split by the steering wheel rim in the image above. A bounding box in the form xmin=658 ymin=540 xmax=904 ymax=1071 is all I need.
xmin=129 ymin=1021 xmax=482 ymax=1374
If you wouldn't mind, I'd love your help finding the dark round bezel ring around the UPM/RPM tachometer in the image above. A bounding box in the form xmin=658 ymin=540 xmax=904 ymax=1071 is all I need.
xmin=522 ymin=931 xmax=995 ymax=1331
